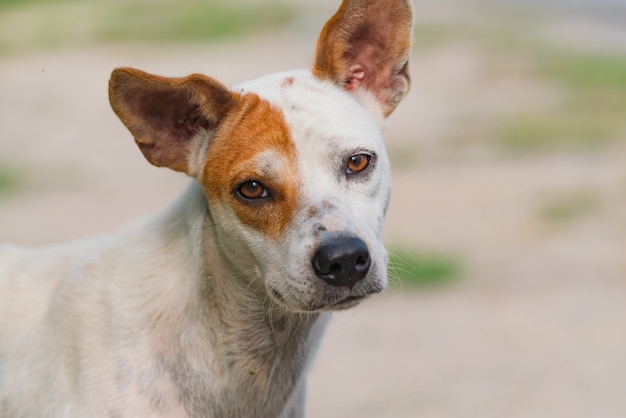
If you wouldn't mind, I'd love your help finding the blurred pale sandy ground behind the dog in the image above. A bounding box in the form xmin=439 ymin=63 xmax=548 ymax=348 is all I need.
xmin=0 ymin=22 xmax=626 ymax=418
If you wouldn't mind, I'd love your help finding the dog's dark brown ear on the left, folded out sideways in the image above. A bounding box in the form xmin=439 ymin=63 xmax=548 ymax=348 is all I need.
xmin=109 ymin=68 xmax=237 ymax=174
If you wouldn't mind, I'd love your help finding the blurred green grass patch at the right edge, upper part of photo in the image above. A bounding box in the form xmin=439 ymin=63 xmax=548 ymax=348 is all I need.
xmin=495 ymin=48 xmax=626 ymax=154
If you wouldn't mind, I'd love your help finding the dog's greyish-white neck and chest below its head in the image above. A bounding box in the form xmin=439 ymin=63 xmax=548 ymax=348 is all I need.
xmin=122 ymin=181 xmax=327 ymax=416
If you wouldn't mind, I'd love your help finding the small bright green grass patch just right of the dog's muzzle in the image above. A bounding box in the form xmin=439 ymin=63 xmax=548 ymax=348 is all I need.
xmin=388 ymin=247 xmax=462 ymax=287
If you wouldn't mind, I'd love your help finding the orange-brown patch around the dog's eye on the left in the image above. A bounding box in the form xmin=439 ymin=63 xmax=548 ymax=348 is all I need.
xmin=203 ymin=94 xmax=302 ymax=238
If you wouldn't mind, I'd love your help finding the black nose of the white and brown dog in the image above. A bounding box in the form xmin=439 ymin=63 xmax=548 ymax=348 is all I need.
xmin=311 ymin=237 xmax=372 ymax=287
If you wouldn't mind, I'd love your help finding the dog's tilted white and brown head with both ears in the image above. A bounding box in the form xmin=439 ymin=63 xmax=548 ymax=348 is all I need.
xmin=110 ymin=0 xmax=412 ymax=312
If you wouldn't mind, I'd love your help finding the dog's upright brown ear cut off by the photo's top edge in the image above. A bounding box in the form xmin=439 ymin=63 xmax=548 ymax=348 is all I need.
xmin=313 ymin=0 xmax=413 ymax=116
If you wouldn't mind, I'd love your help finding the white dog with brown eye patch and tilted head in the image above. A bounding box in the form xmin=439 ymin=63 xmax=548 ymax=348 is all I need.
xmin=0 ymin=0 xmax=413 ymax=418
